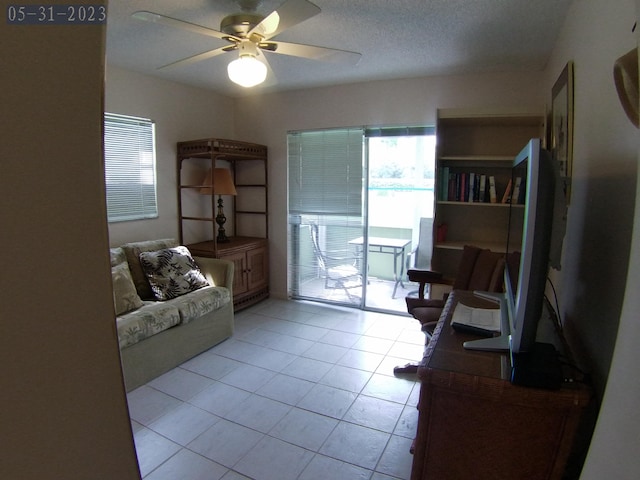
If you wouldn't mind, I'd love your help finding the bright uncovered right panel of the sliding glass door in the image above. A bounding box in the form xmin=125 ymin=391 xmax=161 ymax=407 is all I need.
xmin=365 ymin=129 xmax=435 ymax=313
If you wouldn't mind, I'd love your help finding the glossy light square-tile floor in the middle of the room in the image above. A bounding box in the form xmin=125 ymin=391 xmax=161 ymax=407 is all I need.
xmin=128 ymin=299 xmax=424 ymax=480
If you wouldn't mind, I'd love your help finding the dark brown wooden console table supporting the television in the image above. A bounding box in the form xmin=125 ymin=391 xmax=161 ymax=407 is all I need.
xmin=411 ymin=291 xmax=590 ymax=480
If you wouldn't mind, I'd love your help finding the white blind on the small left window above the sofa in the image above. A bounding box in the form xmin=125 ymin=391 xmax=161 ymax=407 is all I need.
xmin=104 ymin=113 xmax=158 ymax=222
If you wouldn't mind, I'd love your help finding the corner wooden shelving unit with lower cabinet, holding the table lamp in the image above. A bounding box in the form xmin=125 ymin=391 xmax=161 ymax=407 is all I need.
xmin=177 ymin=138 xmax=269 ymax=311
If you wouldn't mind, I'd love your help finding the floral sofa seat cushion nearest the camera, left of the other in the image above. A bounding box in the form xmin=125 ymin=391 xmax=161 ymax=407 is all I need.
xmin=116 ymin=302 xmax=180 ymax=348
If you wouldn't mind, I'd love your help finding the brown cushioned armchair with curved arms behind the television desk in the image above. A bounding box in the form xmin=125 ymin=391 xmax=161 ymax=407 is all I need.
xmin=393 ymin=245 xmax=510 ymax=373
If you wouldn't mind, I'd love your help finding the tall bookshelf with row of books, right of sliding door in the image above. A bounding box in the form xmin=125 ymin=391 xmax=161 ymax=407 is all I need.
xmin=432 ymin=109 xmax=545 ymax=277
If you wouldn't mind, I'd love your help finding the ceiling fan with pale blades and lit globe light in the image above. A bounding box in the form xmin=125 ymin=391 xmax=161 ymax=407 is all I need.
xmin=132 ymin=0 xmax=361 ymax=87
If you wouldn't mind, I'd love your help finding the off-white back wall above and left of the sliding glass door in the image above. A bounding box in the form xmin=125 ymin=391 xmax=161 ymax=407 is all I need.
xmin=235 ymin=73 xmax=545 ymax=298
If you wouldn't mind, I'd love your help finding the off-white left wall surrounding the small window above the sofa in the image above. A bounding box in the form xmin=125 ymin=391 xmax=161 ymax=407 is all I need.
xmin=105 ymin=66 xmax=234 ymax=246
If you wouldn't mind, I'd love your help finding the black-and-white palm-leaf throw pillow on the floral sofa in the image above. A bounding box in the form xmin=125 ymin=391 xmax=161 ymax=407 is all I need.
xmin=140 ymin=246 xmax=209 ymax=300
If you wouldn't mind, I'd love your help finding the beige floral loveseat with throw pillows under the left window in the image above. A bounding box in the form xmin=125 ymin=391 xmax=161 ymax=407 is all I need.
xmin=110 ymin=239 xmax=233 ymax=391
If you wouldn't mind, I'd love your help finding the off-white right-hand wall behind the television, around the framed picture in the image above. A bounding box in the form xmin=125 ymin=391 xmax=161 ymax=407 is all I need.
xmin=546 ymin=0 xmax=637 ymax=396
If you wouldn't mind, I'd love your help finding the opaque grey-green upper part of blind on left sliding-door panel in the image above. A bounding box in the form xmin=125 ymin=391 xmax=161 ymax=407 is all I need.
xmin=288 ymin=128 xmax=364 ymax=217
